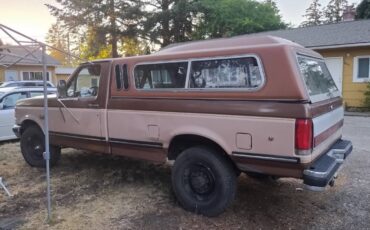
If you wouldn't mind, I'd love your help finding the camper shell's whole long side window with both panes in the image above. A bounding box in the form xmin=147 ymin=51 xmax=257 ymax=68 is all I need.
xmin=134 ymin=55 xmax=265 ymax=91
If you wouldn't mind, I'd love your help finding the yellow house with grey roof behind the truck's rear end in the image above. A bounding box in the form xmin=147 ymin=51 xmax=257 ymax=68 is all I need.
xmin=253 ymin=19 xmax=370 ymax=107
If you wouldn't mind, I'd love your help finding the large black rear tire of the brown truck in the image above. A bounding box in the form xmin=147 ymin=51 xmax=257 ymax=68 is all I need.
xmin=172 ymin=146 xmax=236 ymax=216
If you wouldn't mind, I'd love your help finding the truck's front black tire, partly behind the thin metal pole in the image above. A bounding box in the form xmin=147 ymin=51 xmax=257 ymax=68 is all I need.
xmin=20 ymin=125 xmax=60 ymax=168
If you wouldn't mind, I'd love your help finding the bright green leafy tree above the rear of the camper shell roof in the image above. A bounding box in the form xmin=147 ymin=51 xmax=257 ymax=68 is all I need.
xmin=196 ymin=0 xmax=286 ymax=39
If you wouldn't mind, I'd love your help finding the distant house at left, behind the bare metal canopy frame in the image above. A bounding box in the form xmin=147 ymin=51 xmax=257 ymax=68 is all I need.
xmin=0 ymin=47 xmax=60 ymax=83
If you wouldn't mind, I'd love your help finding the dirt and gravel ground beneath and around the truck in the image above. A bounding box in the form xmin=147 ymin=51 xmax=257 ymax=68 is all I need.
xmin=0 ymin=117 xmax=370 ymax=230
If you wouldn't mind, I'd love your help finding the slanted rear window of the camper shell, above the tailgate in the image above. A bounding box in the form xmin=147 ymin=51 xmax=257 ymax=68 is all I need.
xmin=298 ymin=56 xmax=340 ymax=102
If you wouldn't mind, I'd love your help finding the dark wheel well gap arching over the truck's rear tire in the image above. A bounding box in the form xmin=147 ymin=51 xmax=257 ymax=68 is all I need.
xmin=167 ymin=134 xmax=239 ymax=171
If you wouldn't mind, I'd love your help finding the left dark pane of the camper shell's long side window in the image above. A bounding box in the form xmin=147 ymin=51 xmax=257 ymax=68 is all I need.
xmin=134 ymin=62 xmax=188 ymax=89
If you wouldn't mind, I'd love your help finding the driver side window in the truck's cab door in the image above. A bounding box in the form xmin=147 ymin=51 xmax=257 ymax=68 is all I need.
xmin=67 ymin=64 xmax=101 ymax=97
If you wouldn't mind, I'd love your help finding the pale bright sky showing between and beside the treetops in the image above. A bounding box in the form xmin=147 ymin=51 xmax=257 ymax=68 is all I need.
xmin=0 ymin=0 xmax=361 ymax=42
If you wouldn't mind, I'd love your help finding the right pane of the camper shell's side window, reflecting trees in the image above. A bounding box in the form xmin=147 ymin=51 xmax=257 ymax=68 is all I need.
xmin=189 ymin=57 xmax=263 ymax=89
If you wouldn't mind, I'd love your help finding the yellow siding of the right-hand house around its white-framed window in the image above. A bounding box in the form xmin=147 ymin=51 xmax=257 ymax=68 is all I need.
xmin=317 ymin=47 xmax=370 ymax=107
